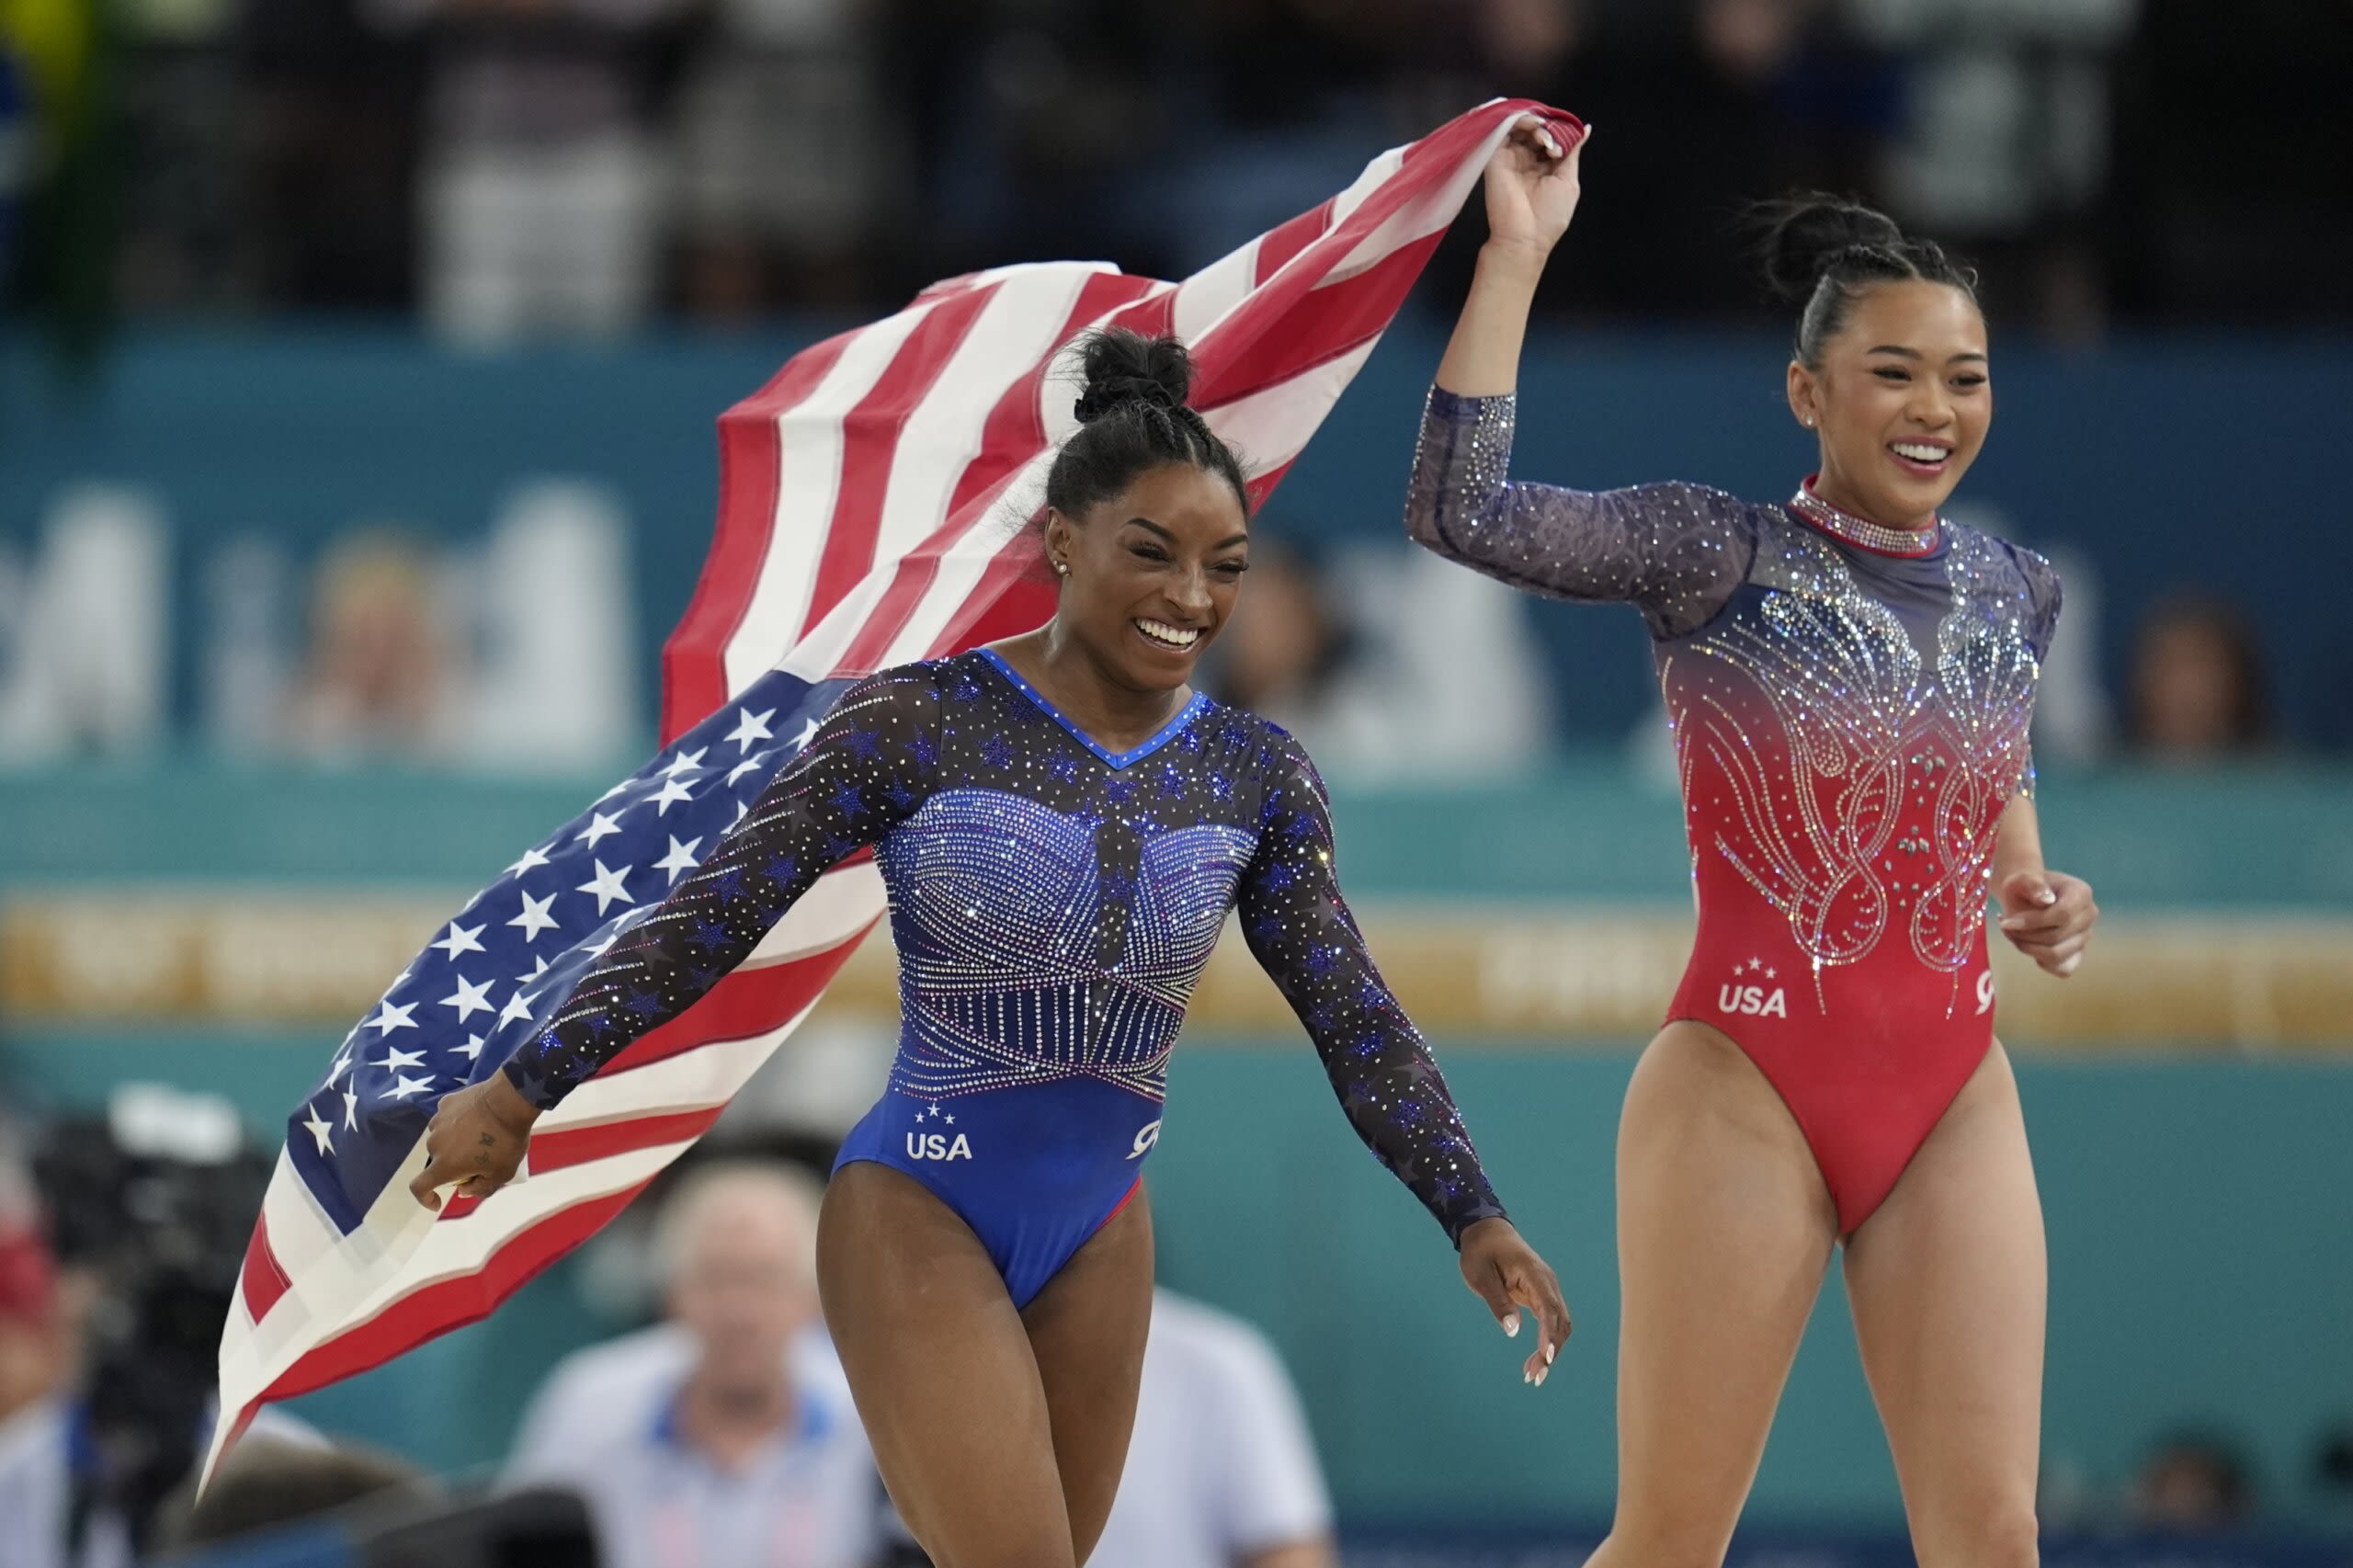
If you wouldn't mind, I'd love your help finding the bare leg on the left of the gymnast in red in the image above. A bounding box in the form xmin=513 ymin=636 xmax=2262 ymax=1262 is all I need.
xmin=1588 ymin=1022 xmax=1837 ymax=1568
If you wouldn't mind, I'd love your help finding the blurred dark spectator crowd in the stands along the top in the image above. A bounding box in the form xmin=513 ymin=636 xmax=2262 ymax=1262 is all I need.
xmin=0 ymin=0 xmax=2353 ymax=341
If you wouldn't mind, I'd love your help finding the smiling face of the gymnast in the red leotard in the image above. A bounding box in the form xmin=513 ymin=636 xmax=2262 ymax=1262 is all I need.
xmin=1789 ymin=282 xmax=1993 ymax=528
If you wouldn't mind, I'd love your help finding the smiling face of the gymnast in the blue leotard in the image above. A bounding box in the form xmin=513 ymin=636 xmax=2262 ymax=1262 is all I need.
xmin=1045 ymin=464 xmax=1249 ymax=692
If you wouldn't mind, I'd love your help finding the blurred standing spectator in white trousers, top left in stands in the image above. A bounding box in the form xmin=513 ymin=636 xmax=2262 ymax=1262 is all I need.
xmin=374 ymin=0 xmax=689 ymax=344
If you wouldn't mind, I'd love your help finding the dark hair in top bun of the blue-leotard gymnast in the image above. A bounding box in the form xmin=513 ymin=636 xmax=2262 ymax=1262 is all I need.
xmin=1045 ymin=327 xmax=1249 ymax=518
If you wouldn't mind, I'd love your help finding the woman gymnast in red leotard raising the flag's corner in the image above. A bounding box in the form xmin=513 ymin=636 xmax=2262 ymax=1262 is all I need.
xmin=1407 ymin=118 xmax=2099 ymax=1568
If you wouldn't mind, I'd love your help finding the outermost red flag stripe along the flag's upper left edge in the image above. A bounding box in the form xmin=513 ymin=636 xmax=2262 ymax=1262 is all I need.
xmin=661 ymin=332 xmax=857 ymax=746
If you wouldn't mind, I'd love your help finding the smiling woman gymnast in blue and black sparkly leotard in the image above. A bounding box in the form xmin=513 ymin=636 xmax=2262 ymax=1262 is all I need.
xmin=412 ymin=332 xmax=1570 ymax=1568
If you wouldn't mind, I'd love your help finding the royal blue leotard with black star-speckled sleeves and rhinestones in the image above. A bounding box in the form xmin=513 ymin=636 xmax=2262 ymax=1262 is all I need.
xmin=506 ymin=647 xmax=1504 ymax=1304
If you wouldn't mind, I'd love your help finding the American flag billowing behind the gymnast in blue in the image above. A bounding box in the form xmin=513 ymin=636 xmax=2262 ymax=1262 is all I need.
xmin=205 ymin=101 xmax=1574 ymax=1476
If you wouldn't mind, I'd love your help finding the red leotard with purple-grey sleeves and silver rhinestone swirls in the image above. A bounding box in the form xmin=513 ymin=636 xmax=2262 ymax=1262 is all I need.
xmin=1407 ymin=389 xmax=2059 ymax=1232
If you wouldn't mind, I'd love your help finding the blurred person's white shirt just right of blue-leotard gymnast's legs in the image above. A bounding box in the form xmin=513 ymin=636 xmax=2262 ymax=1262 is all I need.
xmin=1092 ymin=1290 xmax=1339 ymax=1568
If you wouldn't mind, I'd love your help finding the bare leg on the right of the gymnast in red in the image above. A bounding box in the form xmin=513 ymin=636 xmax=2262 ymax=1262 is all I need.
xmin=1847 ymin=1030 xmax=2047 ymax=1568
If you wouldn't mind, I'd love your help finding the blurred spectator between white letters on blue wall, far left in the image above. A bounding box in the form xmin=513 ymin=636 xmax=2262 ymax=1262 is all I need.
xmin=287 ymin=529 xmax=461 ymax=760
